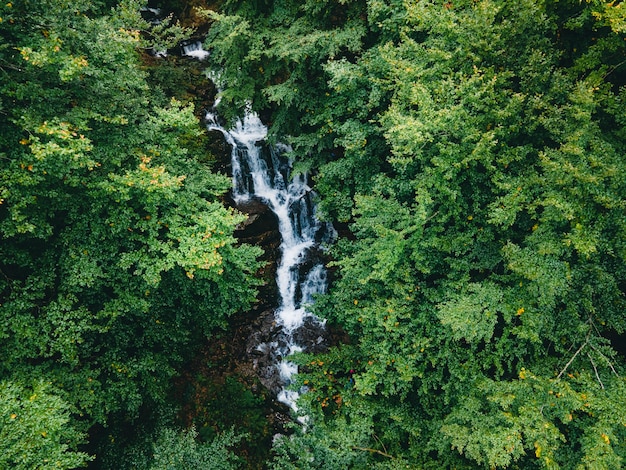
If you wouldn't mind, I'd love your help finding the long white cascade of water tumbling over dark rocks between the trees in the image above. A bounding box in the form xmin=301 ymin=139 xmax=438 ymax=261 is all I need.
xmin=206 ymin=109 xmax=334 ymax=411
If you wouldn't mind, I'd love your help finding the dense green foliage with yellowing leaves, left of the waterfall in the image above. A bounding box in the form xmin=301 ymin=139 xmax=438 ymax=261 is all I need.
xmin=0 ymin=0 xmax=259 ymax=465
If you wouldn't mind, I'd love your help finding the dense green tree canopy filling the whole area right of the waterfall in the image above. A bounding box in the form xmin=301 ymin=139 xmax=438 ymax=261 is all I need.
xmin=208 ymin=0 xmax=626 ymax=468
